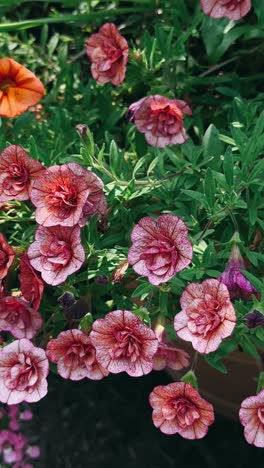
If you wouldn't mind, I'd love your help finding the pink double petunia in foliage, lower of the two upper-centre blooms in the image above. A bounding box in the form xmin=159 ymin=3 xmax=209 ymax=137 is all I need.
xmin=128 ymin=94 xmax=192 ymax=148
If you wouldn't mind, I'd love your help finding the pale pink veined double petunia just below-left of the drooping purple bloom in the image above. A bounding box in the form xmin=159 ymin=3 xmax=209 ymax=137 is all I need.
xmin=174 ymin=279 xmax=236 ymax=354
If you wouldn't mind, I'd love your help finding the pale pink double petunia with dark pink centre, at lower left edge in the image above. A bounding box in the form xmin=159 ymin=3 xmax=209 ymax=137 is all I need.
xmin=0 ymin=339 xmax=49 ymax=405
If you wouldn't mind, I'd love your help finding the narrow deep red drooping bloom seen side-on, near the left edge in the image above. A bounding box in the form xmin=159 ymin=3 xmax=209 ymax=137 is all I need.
xmin=19 ymin=252 xmax=44 ymax=310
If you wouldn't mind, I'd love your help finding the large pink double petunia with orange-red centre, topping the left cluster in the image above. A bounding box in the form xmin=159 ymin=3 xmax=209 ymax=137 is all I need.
xmin=31 ymin=163 xmax=105 ymax=227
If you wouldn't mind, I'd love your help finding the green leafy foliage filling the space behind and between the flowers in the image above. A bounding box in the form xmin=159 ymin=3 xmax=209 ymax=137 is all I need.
xmin=0 ymin=0 xmax=264 ymax=372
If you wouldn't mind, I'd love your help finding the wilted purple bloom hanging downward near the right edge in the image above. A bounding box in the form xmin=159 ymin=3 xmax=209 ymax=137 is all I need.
xmin=218 ymin=245 xmax=258 ymax=300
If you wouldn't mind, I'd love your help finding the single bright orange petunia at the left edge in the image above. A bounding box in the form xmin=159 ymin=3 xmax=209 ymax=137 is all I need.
xmin=0 ymin=57 xmax=45 ymax=117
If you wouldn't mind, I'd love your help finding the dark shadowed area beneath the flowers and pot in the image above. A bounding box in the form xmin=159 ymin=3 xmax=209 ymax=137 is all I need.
xmin=34 ymin=372 xmax=264 ymax=468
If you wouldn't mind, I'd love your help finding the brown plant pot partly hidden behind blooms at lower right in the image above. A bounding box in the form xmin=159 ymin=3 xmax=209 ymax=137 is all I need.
xmin=168 ymin=341 xmax=259 ymax=420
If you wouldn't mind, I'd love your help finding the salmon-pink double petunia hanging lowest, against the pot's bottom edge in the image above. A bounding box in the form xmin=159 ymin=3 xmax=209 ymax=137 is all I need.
xmin=149 ymin=382 xmax=214 ymax=439
